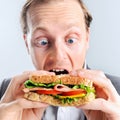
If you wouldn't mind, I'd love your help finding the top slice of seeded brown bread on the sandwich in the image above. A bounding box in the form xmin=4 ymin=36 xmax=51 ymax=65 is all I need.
xmin=29 ymin=74 xmax=92 ymax=87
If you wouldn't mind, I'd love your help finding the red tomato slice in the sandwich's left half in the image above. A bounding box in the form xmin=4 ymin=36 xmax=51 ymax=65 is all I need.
xmin=36 ymin=89 xmax=61 ymax=95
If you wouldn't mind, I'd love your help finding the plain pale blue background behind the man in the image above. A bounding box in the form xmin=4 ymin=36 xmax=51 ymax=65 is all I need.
xmin=0 ymin=0 xmax=120 ymax=80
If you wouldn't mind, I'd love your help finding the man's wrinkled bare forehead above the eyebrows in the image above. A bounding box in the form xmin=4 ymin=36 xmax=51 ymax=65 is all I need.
xmin=27 ymin=0 xmax=85 ymax=31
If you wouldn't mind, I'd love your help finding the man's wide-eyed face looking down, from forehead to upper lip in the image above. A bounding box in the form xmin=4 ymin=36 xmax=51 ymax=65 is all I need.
xmin=25 ymin=0 xmax=89 ymax=72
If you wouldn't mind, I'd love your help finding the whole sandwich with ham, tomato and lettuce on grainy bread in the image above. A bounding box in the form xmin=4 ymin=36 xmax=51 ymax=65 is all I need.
xmin=23 ymin=74 xmax=95 ymax=106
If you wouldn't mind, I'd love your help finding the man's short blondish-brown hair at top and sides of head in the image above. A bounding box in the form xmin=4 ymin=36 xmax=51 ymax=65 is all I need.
xmin=21 ymin=0 xmax=92 ymax=34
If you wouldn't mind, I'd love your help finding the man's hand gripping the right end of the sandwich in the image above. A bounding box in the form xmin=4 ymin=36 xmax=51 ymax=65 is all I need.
xmin=71 ymin=70 xmax=120 ymax=120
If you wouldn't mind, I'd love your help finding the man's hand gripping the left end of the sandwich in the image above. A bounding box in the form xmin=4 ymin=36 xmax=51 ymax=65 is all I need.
xmin=0 ymin=71 xmax=53 ymax=120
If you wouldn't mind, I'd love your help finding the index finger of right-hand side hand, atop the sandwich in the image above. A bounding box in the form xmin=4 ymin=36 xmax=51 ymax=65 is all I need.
xmin=72 ymin=69 xmax=119 ymax=100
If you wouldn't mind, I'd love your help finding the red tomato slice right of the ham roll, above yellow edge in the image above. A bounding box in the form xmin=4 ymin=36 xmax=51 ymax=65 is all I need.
xmin=61 ymin=89 xmax=87 ymax=96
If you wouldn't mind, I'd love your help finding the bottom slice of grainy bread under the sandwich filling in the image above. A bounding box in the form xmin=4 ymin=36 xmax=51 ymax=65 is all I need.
xmin=24 ymin=92 xmax=95 ymax=106
